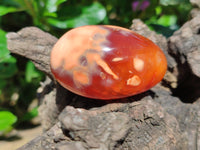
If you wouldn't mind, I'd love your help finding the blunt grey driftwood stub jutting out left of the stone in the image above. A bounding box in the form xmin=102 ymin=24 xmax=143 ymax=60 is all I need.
xmin=7 ymin=27 xmax=57 ymax=77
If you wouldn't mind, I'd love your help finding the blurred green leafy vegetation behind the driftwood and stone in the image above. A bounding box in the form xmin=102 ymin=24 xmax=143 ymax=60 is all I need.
xmin=0 ymin=0 xmax=192 ymax=138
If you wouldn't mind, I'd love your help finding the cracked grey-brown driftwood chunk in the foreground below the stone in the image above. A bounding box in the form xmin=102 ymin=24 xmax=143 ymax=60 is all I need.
xmin=20 ymin=97 xmax=187 ymax=150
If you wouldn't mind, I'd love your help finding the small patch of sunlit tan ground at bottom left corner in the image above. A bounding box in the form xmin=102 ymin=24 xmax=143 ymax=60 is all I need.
xmin=0 ymin=126 xmax=42 ymax=150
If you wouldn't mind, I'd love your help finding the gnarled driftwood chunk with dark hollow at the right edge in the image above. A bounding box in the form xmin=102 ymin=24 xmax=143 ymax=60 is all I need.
xmin=169 ymin=12 xmax=200 ymax=102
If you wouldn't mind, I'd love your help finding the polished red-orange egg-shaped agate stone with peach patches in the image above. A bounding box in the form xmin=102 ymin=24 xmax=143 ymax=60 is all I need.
xmin=51 ymin=25 xmax=167 ymax=100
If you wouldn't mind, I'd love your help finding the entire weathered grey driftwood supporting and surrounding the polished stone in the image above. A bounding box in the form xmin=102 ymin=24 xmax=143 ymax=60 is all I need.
xmin=7 ymin=5 xmax=200 ymax=150
